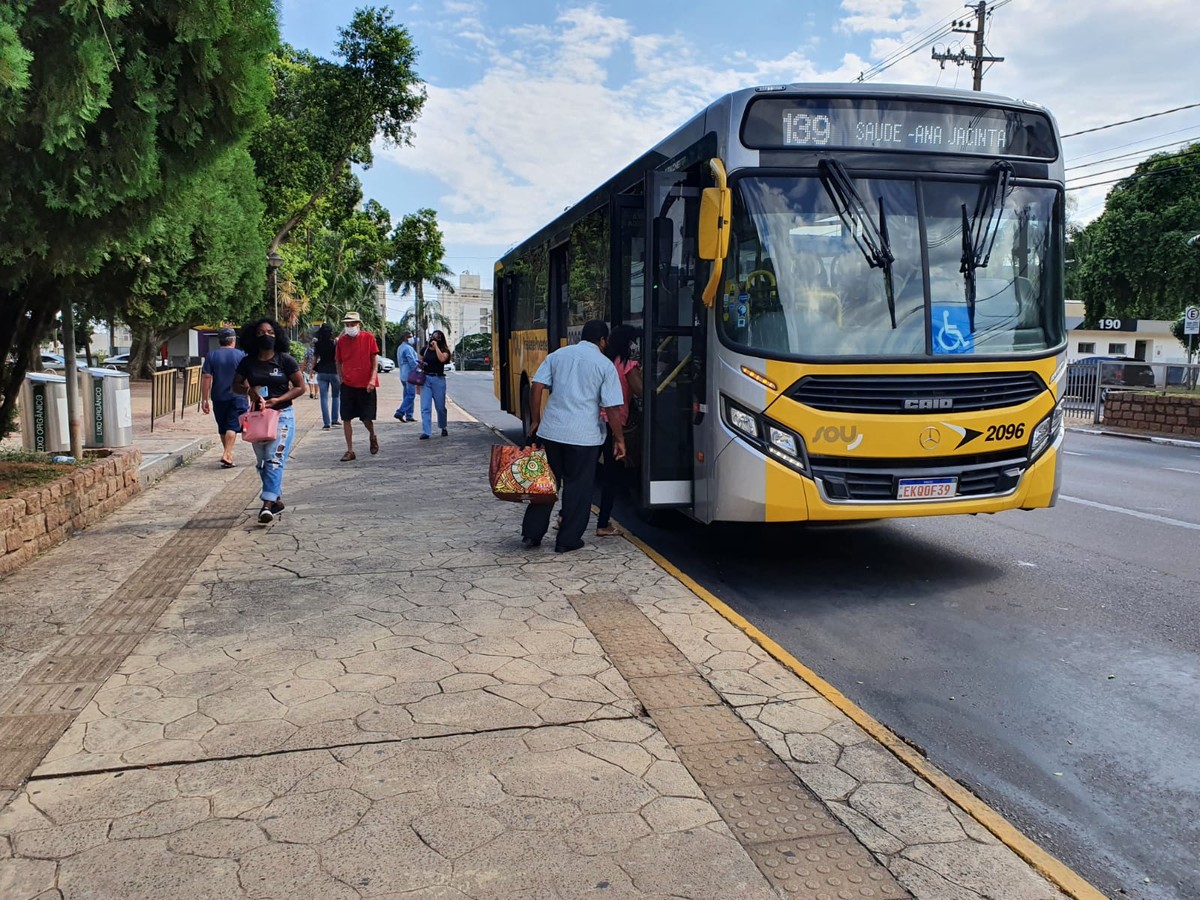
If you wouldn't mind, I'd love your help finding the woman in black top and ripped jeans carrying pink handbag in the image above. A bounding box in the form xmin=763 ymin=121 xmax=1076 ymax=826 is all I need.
xmin=233 ymin=319 xmax=305 ymax=524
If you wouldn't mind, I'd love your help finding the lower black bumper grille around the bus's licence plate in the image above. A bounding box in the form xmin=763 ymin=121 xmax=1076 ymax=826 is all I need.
xmin=809 ymin=452 xmax=1028 ymax=503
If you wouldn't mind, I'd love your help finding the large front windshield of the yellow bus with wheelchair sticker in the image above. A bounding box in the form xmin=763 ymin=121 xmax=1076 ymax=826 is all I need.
xmin=718 ymin=173 xmax=1063 ymax=359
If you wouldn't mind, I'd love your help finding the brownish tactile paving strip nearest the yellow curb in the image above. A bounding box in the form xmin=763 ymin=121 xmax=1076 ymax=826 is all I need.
xmin=571 ymin=593 xmax=908 ymax=900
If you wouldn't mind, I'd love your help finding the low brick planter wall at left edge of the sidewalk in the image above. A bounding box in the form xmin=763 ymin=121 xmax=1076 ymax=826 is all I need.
xmin=0 ymin=448 xmax=142 ymax=576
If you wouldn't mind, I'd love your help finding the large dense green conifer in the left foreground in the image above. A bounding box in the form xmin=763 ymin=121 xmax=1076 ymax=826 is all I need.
xmin=0 ymin=0 xmax=278 ymax=434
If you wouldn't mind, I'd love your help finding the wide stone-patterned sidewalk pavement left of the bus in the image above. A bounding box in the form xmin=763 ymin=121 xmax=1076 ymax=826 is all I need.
xmin=0 ymin=382 xmax=1058 ymax=900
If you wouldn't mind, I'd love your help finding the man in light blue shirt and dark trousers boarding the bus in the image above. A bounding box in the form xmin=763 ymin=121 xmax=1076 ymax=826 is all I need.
xmin=521 ymin=319 xmax=625 ymax=553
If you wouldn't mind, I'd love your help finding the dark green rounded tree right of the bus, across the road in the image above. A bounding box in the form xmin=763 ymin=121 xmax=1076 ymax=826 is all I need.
xmin=1069 ymin=144 xmax=1200 ymax=323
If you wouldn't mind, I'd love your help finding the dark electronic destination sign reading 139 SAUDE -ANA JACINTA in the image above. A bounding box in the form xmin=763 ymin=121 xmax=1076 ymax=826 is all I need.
xmin=743 ymin=97 xmax=1058 ymax=160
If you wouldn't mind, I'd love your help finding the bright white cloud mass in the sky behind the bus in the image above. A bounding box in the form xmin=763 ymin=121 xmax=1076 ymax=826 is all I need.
xmin=379 ymin=0 xmax=1200 ymax=273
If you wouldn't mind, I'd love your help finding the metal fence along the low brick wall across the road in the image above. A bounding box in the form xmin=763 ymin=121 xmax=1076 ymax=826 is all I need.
xmin=1062 ymin=356 xmax=1200 ymax=425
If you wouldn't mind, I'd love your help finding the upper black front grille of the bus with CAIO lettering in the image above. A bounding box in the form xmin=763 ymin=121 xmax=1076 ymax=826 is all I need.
xmin=786 ymin=372 xmax=1046 ymax=415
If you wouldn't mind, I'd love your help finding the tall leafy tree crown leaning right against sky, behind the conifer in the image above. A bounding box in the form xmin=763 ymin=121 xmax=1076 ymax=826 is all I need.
xmin=251 ymin=7 xmax=425 ymax=252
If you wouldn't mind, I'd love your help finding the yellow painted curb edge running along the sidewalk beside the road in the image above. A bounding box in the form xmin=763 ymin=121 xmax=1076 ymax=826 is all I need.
xmin=613 ymin=528 xmax=1105 ymax=900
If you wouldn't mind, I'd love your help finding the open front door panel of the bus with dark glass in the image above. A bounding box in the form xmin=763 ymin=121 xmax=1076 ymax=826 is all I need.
xmin=641 ymin=172 xmax=703 ymax=511
